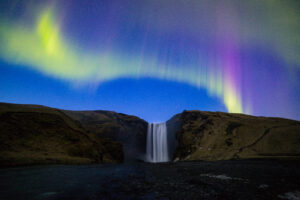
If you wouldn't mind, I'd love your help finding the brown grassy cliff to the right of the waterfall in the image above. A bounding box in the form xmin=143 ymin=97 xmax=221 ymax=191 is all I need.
xmin=167 ymin=111 xmax=300 ymax=160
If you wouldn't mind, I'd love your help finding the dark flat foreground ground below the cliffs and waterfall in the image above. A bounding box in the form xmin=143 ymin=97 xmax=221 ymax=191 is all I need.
xmin=0 ymin=160 xmax=300 ymax=200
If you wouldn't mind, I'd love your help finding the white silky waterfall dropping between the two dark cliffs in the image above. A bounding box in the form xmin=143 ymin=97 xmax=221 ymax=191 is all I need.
xmin=146 ymin=123 xmax=169 ymax=162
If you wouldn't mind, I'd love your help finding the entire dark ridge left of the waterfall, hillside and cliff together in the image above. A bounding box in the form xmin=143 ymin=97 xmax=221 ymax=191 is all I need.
xmin=0 ymin=103 xmax=146 ymax=166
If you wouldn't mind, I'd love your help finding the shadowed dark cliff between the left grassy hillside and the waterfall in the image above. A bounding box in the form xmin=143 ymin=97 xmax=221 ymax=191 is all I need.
xmin=64 ymin=111 xmax=148 ymax=161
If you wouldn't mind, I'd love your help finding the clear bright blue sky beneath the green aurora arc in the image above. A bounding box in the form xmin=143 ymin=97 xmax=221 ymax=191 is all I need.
xmin=0 ymin=62 xmax=226 ymax=122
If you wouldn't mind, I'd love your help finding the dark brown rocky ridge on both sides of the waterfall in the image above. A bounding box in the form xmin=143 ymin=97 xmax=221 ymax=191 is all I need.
xmin=0 ymin=103 xmax=300 ymax=166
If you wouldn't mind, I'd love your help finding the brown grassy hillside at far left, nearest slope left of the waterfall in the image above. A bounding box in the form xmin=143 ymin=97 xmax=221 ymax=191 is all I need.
xmin=0 ymin=103 xmax=123 ymax=166
